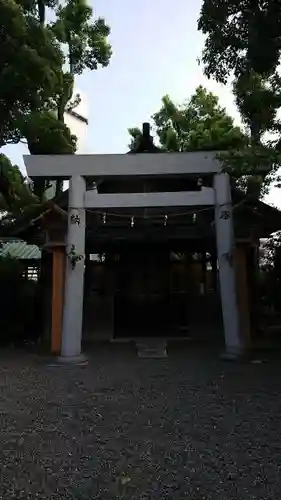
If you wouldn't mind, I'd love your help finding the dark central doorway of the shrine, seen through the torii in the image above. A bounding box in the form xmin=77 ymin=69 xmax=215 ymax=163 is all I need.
xmin=114 ymin=247 xmax=171 ymax=337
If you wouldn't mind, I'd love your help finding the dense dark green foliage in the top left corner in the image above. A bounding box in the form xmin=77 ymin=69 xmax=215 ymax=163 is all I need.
xmin=0 ymin=0 xmax=63 ymax=147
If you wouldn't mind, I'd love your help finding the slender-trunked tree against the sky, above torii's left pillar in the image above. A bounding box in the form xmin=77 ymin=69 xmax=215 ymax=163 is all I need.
xmin=10 ymin=0 xmax=111 ymax=197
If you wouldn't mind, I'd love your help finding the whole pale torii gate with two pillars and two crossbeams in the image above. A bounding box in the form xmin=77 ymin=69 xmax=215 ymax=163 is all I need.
xmin=24 ymin=152 xmax=243 ymax=362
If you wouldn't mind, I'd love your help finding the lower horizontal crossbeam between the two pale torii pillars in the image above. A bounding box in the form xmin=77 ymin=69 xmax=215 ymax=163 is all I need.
xmin=85 ymin=188 xmax=214 ymax=209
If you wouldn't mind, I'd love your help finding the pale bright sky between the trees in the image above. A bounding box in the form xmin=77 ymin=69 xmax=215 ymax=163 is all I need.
xmin=0 ymin=0 xmax=281 ymax=206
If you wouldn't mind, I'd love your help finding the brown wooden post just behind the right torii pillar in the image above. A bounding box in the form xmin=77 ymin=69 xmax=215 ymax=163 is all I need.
xmin=234 ymin=243 xmax=251 ymax=349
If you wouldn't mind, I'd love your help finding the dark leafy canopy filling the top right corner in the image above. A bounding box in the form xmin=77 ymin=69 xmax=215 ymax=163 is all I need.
xmin=198 ymin=0 xmax=281 ymax=83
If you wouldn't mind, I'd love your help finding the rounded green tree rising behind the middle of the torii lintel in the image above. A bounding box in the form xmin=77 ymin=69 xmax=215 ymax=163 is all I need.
xmin=129 ymin=86 xmax=244 ymax=152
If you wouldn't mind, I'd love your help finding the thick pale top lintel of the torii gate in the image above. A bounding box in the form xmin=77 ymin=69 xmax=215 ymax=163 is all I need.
xmin=24 ymin=151 xmax=221 ymax=179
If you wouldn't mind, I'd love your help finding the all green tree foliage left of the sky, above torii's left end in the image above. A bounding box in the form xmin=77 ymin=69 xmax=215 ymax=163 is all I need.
xmin=0 ymin=0 xmax=111 ymax=208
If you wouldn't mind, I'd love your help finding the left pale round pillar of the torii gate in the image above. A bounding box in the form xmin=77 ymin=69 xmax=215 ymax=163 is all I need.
xmin=60 ymin=175 xmax=86 ymax=362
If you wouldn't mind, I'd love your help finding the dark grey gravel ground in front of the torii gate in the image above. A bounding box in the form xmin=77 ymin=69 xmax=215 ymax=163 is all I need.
xmin=0 ymin=345 xmax=281 ymax=500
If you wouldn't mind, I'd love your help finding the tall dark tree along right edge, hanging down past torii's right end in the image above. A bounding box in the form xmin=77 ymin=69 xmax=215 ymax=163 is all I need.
xmin=198 ymin=0 xmax=281 ymax=196
